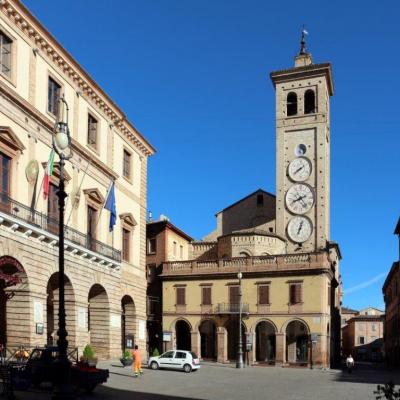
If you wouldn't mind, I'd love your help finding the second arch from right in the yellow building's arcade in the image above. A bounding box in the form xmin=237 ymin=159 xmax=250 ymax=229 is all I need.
xmin=255 ymin=319 xmax=277 ymax=364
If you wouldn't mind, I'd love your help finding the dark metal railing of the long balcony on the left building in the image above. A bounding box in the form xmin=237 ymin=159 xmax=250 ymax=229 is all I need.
xmin=0 ymin=193 xmax=121 ymax=262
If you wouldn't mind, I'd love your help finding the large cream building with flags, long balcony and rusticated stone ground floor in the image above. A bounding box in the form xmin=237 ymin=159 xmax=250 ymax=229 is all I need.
xmin=0 ymin=0 xmax=154 ymax=358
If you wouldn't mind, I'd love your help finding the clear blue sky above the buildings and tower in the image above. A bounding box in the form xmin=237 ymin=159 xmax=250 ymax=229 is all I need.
xmin=24 ymin=0 xmax=400 ymax=308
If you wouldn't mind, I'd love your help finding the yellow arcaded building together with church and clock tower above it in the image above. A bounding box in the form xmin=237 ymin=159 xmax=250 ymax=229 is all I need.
xmin=162 ymin=40 xmax=341 ymax=367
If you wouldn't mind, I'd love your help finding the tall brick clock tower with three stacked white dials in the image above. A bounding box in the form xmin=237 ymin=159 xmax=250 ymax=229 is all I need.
xmin=271 ymin=33 xmax=333 ymax=253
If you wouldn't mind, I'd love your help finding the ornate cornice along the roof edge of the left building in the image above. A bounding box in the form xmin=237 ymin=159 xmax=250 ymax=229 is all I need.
xmin=0 ymin=0 xmax=155 ymax=156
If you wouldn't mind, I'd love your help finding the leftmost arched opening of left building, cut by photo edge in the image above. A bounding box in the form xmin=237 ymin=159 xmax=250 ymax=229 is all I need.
xmin=0 ymin=255 xmax=31 ymax=346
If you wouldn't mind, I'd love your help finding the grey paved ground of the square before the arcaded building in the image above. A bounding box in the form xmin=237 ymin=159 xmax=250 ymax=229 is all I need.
xmin=11 ymin=361 xmax=400 ymax=400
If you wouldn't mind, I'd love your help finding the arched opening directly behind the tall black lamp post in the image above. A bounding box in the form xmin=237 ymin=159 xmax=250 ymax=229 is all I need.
xmin=46 ymin=272 xmax=76 ymax=347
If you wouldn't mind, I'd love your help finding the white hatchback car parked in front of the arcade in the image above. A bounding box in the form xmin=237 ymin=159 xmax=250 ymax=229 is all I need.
xmin=148 ymin=350 xmax=200 ymax=373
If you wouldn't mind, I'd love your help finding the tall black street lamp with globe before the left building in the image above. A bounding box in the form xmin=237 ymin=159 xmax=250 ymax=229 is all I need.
xmin=49 ymin=96 xmax=75 ymax=400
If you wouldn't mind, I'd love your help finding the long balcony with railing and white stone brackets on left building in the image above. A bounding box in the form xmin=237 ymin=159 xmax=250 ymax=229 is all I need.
xmin=0 ymin=193 xmax=121 ymax=268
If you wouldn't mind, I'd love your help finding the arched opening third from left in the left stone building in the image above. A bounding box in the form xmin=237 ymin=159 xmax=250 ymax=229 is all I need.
xmin=88 ymin=283 xmax=110 ymax=359
